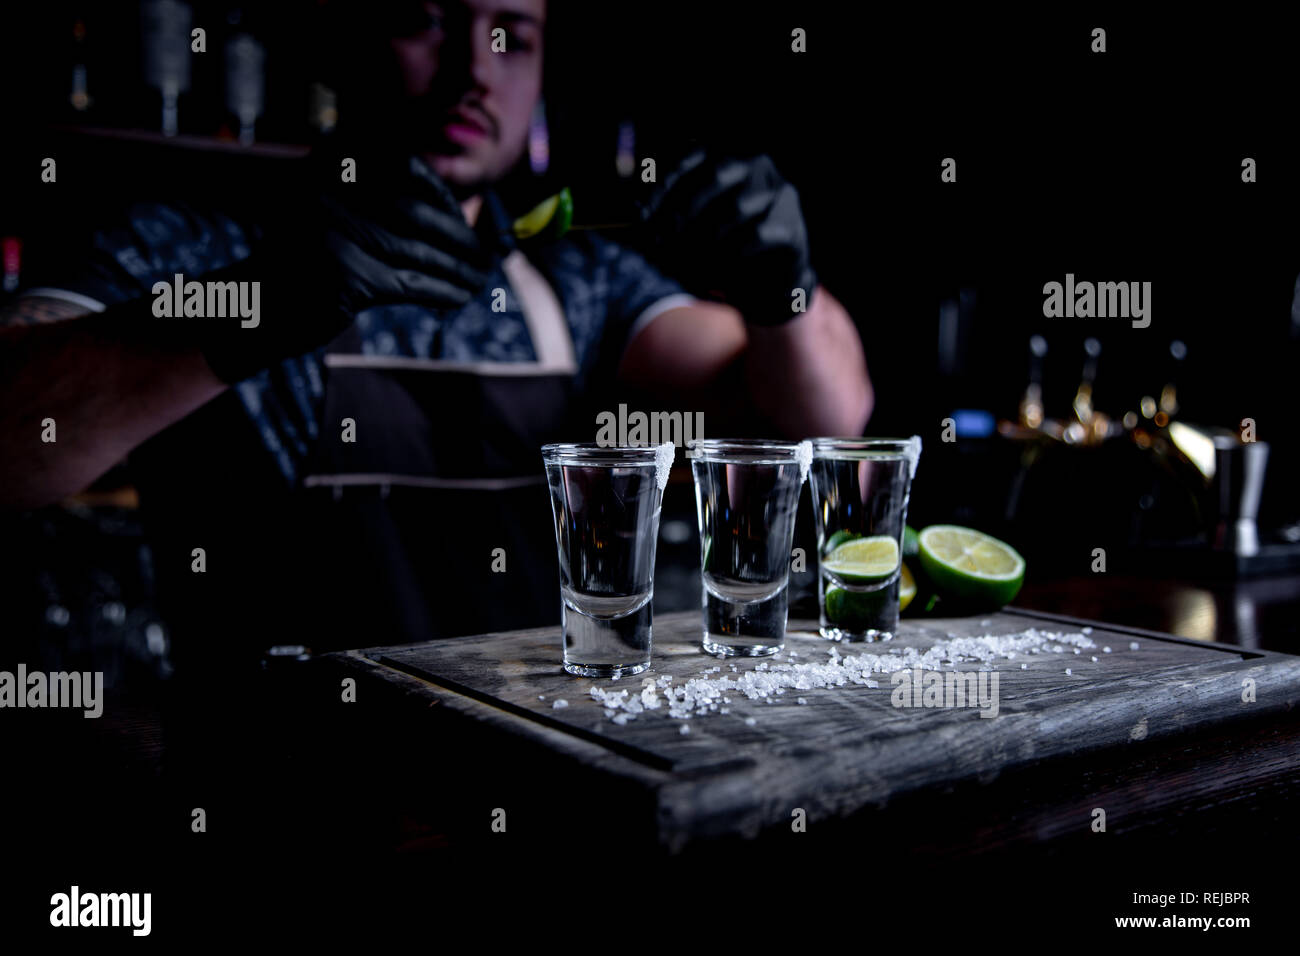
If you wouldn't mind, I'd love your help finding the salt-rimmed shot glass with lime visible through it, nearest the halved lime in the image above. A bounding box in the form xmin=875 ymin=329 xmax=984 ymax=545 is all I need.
xmin=811 ymin=436 xmax=920 ymax=641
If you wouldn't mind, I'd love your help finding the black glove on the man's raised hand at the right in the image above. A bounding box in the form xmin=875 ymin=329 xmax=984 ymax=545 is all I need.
xmin=644 ymin=151 xmax=816 ymax=325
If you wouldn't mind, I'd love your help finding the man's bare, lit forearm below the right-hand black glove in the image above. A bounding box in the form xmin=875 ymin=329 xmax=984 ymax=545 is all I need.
xmin=745 ymin=286 xmax=875 ymax=438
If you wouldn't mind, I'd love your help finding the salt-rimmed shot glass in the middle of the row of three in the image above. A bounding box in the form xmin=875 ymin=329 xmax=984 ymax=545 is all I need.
xmin=686 ymin=438 xmax=813 ymax=657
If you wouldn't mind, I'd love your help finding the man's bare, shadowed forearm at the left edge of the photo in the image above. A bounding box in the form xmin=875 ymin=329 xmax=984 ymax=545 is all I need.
xmin=0 ymin=299 xmax=225 ymax=507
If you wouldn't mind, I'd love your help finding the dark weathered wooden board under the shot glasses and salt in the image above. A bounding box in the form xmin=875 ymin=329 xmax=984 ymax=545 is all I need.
xmin=329 ymin=610 xmax=1300 ymax=848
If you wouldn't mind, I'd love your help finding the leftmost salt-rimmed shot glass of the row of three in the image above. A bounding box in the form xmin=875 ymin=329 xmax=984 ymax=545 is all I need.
xmin=542 ymin=444 xmax=675 ymax=678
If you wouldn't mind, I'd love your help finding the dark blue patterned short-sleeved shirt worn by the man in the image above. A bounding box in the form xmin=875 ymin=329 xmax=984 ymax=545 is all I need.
xmin=27 ymin=199 xmax=692 ymax=484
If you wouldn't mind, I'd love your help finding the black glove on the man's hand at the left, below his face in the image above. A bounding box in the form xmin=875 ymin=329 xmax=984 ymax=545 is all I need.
xmin=197 ymin=157 xmax=491 ymax=382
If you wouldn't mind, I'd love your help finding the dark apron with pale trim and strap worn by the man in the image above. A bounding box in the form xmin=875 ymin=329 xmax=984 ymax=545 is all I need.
xmin=302 ymin=250 xmax=577 ymax=650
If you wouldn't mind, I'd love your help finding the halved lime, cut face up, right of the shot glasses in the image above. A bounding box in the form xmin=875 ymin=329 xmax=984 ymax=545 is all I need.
xmin=919 ymin=524 xmax=1024 ymax=607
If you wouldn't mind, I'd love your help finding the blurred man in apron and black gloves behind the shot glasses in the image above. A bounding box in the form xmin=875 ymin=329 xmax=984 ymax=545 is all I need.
xmin=0 ymin=0 xmax=872 ymax=666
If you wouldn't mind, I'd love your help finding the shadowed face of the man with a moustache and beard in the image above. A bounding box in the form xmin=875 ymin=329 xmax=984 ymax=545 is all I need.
xmin=389 ymin=0 xmax=546 ymax=190
